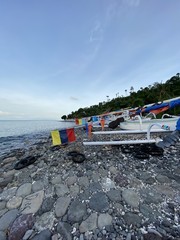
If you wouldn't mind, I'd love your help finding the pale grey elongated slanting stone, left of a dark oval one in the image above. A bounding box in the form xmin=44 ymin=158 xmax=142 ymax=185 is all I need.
xmin=55 ymin=197 xmax=71 ymax=217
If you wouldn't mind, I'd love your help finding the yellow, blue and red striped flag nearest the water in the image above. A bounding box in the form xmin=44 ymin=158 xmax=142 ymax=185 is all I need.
xmin=51 ymin=128 xmax=76 ymax=145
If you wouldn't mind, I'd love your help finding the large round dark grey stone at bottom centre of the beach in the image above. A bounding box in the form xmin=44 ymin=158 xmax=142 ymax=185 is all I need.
xmin=89 ymin=192 xmax=109 ymax=212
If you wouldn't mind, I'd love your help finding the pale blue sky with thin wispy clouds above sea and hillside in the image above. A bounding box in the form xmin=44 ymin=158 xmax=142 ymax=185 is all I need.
xmin=0 ymin=0 xmax=180 ymax=120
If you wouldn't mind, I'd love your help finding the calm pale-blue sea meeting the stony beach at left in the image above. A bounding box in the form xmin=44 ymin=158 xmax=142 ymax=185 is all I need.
xmin=0 ymin=120 xmax=75 ymax=156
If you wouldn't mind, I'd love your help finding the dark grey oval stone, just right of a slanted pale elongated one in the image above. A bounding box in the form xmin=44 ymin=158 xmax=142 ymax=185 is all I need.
xmin=68 ymin=200 xmax=86 ymax=223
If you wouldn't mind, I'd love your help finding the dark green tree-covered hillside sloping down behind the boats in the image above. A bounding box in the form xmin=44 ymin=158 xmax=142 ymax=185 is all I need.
xmin=63 ymin=73 xmax=180 ymax=119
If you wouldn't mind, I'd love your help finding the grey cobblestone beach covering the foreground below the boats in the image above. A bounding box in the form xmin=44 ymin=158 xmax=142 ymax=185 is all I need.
xmin=0 ymin=128 xmax=180 ymax=240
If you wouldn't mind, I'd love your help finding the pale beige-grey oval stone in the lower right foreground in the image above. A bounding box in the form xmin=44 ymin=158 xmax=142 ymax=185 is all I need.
xmin=122 ymin=189 xmax=140 ymax=208
